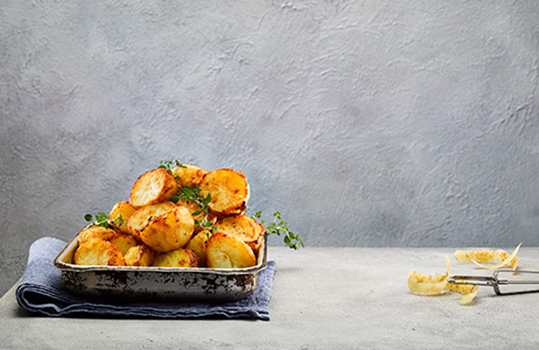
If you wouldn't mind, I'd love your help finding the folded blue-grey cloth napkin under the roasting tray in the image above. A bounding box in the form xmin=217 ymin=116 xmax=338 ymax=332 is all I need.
xmin=16 ymin=237 xmax=275 ymax=320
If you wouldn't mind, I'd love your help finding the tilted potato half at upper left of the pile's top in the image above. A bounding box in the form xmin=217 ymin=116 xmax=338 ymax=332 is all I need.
xmin=129 ymin=168 xmax=178 ymax=208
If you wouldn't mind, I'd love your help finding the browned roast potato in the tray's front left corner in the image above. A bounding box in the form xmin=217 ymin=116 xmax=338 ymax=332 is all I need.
xmin=73 ymin=238 xmax=125 ymax=266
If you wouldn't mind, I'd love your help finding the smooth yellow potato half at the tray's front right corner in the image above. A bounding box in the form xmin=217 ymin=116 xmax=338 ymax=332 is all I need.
xmin=206 ymin=233 xmax=256 ymax=269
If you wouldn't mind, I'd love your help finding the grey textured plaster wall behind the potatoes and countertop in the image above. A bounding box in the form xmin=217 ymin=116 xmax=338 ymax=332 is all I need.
xmin=0 ymin=0 xmax=539 ymax=294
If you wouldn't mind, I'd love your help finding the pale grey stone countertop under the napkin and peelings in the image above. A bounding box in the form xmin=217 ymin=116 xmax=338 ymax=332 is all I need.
xmin=0 ymin=247 xmax=539 ymax=350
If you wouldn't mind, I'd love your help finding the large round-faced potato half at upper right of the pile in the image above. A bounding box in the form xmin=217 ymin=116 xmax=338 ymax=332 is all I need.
xmin=200 ymin=169 xmax=250 ymax=216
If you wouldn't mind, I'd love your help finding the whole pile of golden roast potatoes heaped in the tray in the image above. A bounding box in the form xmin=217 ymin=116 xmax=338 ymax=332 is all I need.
xmin=73 ymin=163 xmax=264 ymax=269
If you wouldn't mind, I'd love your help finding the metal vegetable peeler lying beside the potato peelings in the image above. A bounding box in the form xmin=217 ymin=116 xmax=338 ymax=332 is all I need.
xmin=447 ymin=270 xmax=539 ymax=295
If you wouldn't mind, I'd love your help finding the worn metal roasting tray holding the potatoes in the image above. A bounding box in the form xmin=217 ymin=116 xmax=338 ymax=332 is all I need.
xmin=54 ymin=234 xmax=267 ymax=301
